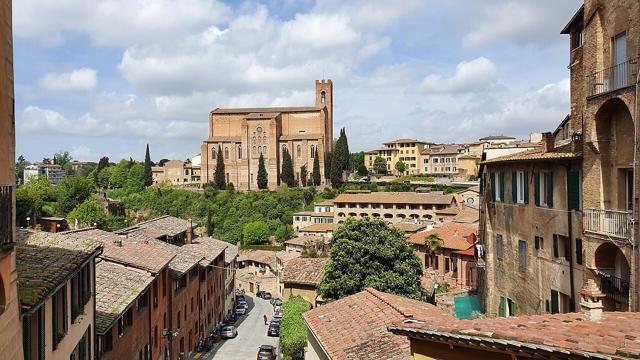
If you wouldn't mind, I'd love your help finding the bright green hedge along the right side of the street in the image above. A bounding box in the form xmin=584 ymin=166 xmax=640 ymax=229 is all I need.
xmin=280 ymin=296 xmax=311 ymax=360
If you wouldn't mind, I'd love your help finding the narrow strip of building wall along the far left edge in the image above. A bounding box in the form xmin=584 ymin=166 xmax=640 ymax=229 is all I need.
xmin=0 ymin=0 xmax=23 ymax=359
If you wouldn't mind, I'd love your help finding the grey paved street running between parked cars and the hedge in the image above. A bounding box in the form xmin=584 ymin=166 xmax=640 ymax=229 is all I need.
xmin=196 ymin=294 xmax=278 ymax=360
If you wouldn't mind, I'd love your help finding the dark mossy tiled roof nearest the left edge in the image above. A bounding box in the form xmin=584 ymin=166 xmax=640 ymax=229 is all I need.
xmin=15 ymin=230 xmax=102 ymax=307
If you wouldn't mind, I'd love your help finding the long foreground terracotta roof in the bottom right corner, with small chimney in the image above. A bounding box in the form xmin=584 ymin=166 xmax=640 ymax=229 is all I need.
xmin=390 ymin=312 xmax=640 ymax=359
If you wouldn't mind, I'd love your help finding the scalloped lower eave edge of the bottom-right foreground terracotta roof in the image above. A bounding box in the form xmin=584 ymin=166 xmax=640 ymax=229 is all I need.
xmin=387 ymin=325 xmax=619 ymax=360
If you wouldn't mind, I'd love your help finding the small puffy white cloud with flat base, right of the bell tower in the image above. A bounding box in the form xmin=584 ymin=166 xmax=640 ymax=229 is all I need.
xmin=420 ymin=57 xmax=497 ymax=93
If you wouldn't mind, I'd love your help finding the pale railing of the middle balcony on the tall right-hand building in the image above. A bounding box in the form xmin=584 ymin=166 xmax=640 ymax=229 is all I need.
xmin=582 ymin=209 xmax=631 ymax=239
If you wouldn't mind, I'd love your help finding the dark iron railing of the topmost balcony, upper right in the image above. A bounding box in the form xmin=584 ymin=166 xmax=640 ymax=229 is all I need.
xmin=587 ymin=58 xmax=638 ymax=97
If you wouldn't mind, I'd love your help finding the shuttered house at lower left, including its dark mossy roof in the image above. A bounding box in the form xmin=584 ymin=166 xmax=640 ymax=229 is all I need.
xmin=17 ymin=230 xmax=102 ymax=360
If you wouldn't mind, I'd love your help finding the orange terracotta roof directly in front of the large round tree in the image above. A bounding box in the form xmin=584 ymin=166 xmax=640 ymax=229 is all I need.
xmin=302 ymin=288 xmax=453 ymax=360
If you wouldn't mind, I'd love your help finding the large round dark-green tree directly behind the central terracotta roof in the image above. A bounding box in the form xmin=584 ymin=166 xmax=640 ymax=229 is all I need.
xmin=319 ymin=218 xmax=424 ymax=300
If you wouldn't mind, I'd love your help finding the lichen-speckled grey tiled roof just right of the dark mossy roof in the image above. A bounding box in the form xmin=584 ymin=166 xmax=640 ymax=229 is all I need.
xmin=96 ymin=260 xmax=154 ymax=335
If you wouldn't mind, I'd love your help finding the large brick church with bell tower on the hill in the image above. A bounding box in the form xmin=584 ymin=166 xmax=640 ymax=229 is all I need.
xmin=201 ymin=80 xmax=333 ymax=190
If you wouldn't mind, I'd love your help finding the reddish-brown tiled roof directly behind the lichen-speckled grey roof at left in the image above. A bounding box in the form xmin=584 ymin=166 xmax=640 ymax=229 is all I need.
xmin=68 ymin=228 xmax=176 ymax=274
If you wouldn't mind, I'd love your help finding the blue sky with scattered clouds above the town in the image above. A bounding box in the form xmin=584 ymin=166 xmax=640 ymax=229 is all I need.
xmin=13 ymin=0 xmax=581 ymax=161
